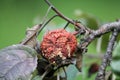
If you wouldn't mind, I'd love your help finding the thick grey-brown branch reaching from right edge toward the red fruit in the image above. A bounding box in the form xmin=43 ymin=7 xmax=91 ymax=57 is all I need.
xmin=78 ymin=21 xmax=120 ymax=49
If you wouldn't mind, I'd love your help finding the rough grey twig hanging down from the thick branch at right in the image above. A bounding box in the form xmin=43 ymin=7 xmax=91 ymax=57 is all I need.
xmin=96 ymin=29 xmax=118 ymax=80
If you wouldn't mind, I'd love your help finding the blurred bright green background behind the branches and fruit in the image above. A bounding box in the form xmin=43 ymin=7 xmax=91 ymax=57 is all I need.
xmin=0 ymin=0 xmax=120 ymax=80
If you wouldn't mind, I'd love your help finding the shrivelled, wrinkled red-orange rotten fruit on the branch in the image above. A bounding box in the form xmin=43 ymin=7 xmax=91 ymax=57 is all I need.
xmin=40 ymin=29 xmax=77 ymax=63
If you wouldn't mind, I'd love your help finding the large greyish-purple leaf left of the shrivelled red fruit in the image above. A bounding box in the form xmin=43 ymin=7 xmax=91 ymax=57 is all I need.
xmin=0 ymin=44 xmax=37 ymax=80
